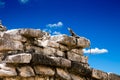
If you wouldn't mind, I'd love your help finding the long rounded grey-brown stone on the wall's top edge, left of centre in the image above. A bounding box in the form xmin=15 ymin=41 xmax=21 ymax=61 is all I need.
xmin=19 ymin=29 xmax=45 ymax=38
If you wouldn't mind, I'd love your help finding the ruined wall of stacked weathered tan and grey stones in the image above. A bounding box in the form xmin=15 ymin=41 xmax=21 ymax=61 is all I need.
xmin=0 ymin=24 xmax=120 ymax=80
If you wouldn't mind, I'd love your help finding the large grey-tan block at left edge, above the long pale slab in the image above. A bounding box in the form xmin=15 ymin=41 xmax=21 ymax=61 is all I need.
xmin=0 ymin=38 xmax=23 ymax=51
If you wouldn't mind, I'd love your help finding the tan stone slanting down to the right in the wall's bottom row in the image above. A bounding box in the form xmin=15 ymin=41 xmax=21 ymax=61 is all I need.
xmin=56 ymin=68 xmax=71 ymax=80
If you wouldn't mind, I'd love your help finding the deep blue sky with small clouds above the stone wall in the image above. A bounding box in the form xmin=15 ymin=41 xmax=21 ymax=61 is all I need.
xmin=0 ymin=0 xmax=120 ymax=74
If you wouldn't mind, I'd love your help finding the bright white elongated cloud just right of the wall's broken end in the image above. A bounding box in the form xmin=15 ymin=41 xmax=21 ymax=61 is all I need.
xmin=83 ymin=48 xmax=108 ymax=54
